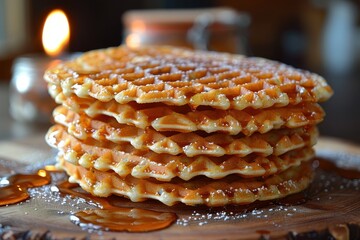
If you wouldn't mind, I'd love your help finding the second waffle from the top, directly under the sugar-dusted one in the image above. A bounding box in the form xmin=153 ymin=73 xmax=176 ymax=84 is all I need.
xmin=52 ymin=94 xmax=325 ymax=136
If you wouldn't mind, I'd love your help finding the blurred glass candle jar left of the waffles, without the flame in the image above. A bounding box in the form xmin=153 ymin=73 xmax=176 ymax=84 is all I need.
xmin=9 ymin=54 xmax=60 ymax=123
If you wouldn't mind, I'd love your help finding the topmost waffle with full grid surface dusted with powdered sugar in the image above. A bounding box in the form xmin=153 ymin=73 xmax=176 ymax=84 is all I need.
xmin=45 ymin=46 xmax=332 ymax=110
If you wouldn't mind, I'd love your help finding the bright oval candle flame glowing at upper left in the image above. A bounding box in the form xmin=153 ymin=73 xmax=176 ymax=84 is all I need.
xmin=42 ymin=9 xmax=70 ymax=56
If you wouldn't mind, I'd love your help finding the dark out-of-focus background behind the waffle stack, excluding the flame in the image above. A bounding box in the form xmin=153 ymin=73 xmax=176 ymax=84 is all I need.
xmin=0 ymin=0 xmax=360 ymax=143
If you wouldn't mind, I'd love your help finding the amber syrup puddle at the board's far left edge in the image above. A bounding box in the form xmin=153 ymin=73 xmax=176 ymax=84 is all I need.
xmin=0 ymin=169 xmax=51 ymax=206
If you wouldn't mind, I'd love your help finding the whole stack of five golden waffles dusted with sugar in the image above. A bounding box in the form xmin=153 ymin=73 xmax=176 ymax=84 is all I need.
xmin=45 ymin=46 xmax=332 ymax=206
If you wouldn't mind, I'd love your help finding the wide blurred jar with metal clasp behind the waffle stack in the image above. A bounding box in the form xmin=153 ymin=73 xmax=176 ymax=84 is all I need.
xmin=123 ymin=8 xmax=250 ymax=54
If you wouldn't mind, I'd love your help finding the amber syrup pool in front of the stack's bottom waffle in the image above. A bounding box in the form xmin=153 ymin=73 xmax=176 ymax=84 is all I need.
xmin=58 ymin=181 xmax=177 ymax=232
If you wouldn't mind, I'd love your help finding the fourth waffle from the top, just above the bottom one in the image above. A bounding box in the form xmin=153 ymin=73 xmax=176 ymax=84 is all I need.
xmin=46 ymin=125 xmax=314 ymax=181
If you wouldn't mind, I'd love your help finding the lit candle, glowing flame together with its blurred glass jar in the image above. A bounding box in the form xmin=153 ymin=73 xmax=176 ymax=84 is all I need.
xmin=10 ymin=9 xmax=72 ymax=123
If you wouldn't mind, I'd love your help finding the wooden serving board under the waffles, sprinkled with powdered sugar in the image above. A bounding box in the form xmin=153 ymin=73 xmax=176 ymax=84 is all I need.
xmin=0 ymin=136 xmax=360 ymax=240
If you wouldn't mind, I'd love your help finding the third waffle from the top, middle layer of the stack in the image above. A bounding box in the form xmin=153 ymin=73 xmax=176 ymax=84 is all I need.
xmin=53 ymin=106 xmax=317 ymax=157
